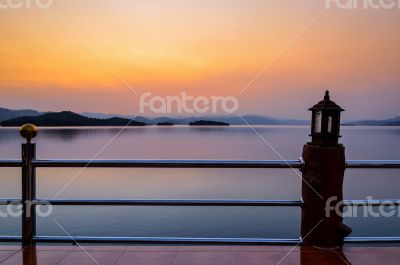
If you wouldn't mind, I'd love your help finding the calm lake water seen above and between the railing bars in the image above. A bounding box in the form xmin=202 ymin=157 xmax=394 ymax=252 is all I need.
xmin=0 ymin=126 xmax=400 ymax=238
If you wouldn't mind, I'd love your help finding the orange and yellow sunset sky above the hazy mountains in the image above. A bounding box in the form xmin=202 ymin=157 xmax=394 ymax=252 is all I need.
xmin=0 ymin=0 xmax=400 ymax=119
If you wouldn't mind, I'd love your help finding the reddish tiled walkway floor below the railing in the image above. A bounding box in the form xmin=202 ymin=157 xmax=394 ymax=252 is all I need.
xmin=0 ymin=243 xmax=400 ymax=265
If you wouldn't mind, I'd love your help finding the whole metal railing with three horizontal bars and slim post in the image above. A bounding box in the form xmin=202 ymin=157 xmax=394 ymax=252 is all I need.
xmin=0 ymin=141 xmax=400 ymax=245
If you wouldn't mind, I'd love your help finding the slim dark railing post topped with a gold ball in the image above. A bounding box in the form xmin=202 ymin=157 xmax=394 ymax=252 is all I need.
xmin=20 ymin=124 xmax=37 ymax=247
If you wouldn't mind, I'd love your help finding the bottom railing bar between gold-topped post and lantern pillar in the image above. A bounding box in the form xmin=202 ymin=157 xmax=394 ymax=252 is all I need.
xmin=34 ymin=236 xmax=300 ymax=245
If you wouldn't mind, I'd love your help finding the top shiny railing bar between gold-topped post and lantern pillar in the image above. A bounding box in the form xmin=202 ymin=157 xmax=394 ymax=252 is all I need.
xmin=32 ymin=160 xmax=303 ymax=168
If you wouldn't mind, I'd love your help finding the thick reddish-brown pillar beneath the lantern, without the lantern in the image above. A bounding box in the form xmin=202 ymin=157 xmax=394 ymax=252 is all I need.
xmin=301 ymin=144 xmax=351 ymax=247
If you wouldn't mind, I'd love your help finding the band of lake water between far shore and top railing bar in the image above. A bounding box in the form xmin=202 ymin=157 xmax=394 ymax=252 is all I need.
xmin=0 ymin=126 xmax=400 ymax=159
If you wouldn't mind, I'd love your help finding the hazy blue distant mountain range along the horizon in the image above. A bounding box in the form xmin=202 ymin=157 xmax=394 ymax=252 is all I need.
xmin=0 ymin=105 xmax=400 ymax=126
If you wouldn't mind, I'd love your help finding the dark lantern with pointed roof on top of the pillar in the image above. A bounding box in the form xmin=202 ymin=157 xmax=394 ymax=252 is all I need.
xmin=309 ymin=91 xmax=344 ymax=145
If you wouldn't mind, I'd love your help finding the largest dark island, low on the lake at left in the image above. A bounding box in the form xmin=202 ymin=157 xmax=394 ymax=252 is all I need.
xmin=1 ymin=111 xmax=146 ymax=127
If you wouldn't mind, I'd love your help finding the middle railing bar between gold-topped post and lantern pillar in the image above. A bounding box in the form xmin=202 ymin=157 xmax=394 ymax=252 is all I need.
xmin=33 ymin=199 xmax=303 ymax=207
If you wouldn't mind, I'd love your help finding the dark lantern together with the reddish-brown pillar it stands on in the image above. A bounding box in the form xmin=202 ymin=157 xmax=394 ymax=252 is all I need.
xmin=301 ymin=91 xmax=352 ymax=248
